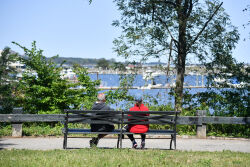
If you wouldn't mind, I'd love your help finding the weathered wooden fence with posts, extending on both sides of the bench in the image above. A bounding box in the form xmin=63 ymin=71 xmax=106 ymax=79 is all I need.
xmin=0 ymin=111 xmax=250 ymax=138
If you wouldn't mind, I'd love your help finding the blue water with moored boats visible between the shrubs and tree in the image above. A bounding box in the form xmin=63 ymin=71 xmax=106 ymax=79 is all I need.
xmin=89 ymin=74 xmax=207 ymax=109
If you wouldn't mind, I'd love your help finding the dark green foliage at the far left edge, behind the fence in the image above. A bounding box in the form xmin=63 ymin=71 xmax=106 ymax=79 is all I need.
xmin=0 ymin=47 xmax=17 ymax=114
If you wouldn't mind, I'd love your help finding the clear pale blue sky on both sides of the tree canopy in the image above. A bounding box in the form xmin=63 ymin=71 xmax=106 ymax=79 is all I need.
xmin=0 ymin=0 xmax=250 ymax=64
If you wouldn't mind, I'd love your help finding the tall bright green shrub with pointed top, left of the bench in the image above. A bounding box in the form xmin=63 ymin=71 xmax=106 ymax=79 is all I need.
xmin=13 ymin=41 xmax=69 ymax=114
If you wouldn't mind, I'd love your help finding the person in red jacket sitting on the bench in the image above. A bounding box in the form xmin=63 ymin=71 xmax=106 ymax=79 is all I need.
xmin=128 ymin=98 xmax=149 ymax=149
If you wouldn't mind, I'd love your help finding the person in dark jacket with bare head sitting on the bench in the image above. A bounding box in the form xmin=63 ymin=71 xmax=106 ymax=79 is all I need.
xmin=89 ymin=93 xmax=114 ymax=147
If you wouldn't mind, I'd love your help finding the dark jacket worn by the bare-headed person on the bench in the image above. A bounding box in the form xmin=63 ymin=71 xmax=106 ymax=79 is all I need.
xmin=90 ymin=103 xmax=114 ymax=132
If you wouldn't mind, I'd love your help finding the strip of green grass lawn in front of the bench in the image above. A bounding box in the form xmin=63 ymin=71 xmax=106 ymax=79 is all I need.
xmin=0 ymin=148 xmax=250 ymax=167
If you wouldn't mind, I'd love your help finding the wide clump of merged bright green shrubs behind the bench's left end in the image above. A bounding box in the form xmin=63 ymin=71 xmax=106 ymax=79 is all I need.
xmin=13 ymin=41 xmax=100 ymax=114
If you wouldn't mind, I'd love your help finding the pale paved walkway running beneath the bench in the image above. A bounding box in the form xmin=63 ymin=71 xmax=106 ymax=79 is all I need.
xmin=0 ymin=137 xmax=250 ymax=153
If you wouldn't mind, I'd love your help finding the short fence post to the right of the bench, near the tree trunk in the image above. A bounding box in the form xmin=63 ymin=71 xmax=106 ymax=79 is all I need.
xmin=196 ymin=110 xmax=207 ymax=139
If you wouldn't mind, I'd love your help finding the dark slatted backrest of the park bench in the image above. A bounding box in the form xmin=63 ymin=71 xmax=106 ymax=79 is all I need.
xmin=64 ymin=109 xmax=179 ymax=125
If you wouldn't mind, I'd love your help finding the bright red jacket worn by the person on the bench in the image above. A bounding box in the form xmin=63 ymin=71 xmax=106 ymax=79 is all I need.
xmin=128 ymin=104 xmax=149 ymax=133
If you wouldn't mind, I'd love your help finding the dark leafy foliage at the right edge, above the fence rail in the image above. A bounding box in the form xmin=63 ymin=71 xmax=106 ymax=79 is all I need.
xmin=196 ymin=60 xmax=250 ymax=117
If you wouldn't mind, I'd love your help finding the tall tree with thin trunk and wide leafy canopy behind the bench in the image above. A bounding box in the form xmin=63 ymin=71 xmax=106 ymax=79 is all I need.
xmin=113 ymin=0 xmax=239 ymax=110
